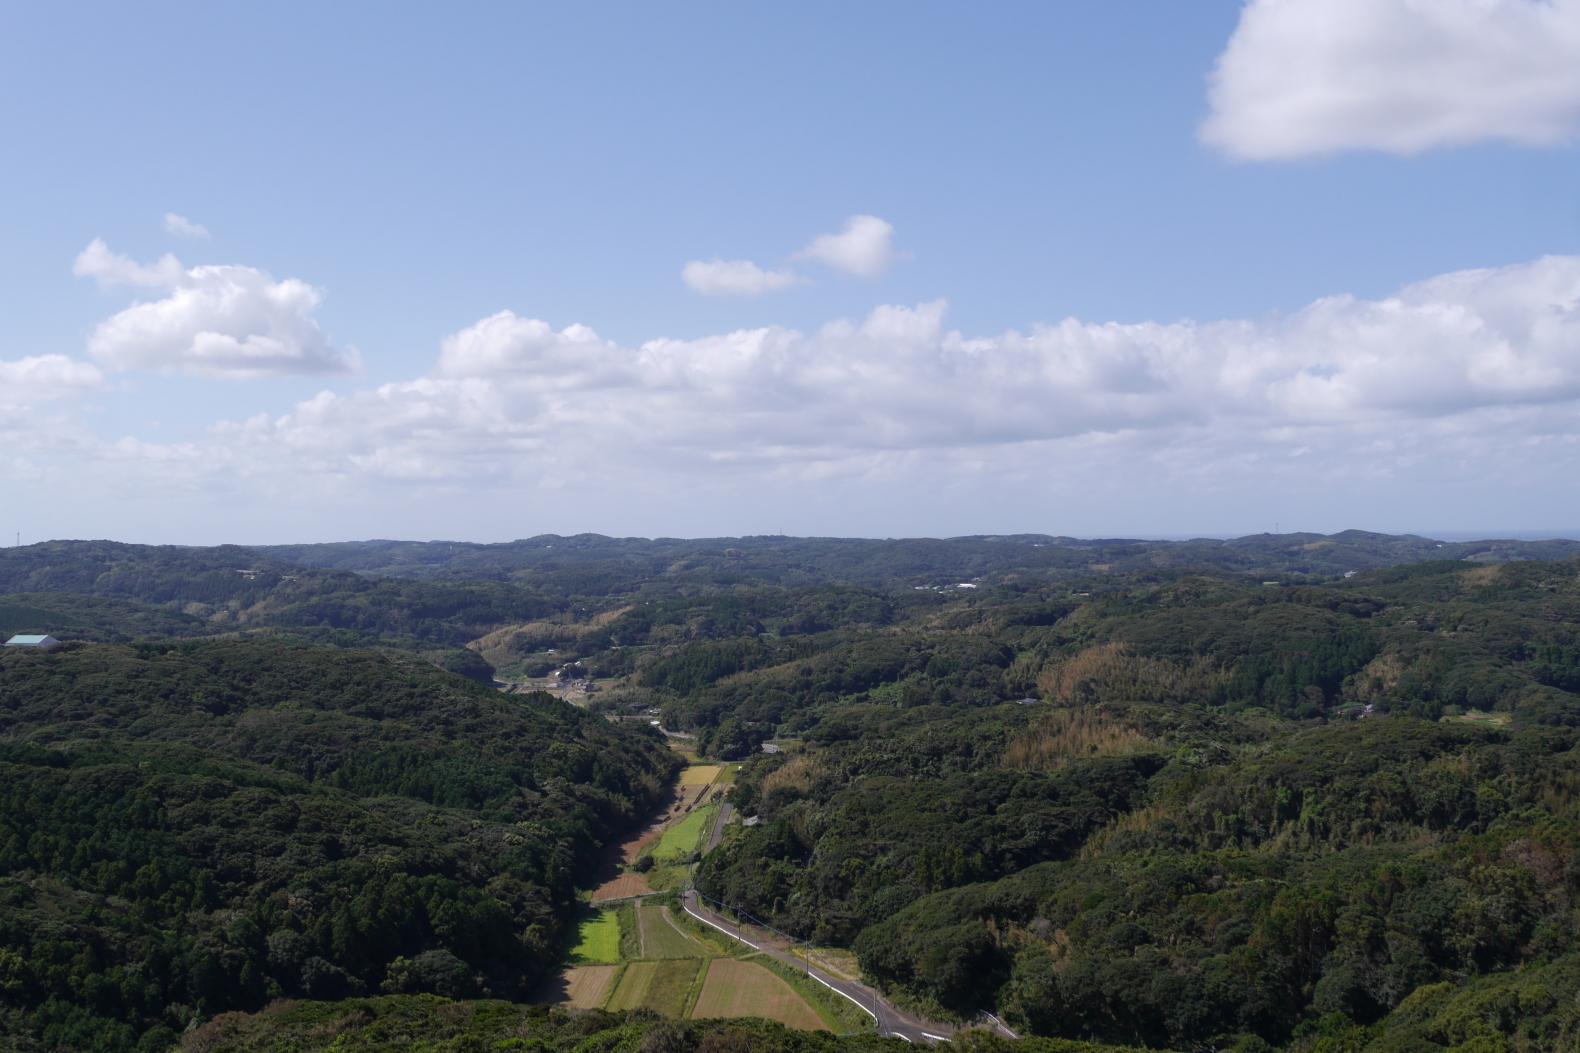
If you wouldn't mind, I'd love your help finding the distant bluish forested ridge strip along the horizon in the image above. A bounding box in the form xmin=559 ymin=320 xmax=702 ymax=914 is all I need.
xmin=258 ymin=530 xmax=1580 ymax=594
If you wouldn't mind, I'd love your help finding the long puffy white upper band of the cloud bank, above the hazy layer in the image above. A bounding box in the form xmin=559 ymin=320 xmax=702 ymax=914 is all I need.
xmin=179 ymin=256 xmax=1580 ymax=481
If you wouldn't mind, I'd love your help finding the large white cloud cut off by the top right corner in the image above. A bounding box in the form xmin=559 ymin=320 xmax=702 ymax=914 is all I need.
xmin=1201 ymin=0 xmax=1580 ymax=161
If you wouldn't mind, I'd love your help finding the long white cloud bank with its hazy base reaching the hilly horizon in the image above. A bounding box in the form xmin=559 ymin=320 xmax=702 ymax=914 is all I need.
xmin=21 ymin=256 xmax=1580 ymax=536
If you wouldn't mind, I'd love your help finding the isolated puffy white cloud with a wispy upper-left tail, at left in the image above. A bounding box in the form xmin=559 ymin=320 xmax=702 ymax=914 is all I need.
xmin=73 ymin=239 xmax=357 ymax=378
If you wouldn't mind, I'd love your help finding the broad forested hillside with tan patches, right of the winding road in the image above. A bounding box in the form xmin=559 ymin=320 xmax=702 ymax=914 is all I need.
xmin=685 ymin=560 xmax=1580 ymax=1053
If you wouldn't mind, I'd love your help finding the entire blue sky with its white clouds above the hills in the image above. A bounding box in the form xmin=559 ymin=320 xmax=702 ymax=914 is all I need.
xmin=0 ymin=0 xmax=1580 ymax=542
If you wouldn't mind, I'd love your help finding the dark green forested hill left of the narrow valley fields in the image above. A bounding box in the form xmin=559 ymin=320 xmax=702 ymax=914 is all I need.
xmin=0 ymin=640 xmax=676 ymax=1050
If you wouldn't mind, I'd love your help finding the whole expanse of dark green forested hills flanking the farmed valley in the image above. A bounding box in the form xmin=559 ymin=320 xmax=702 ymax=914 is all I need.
xmin=0 ymin=531 xmax=1580 ymax=1053
